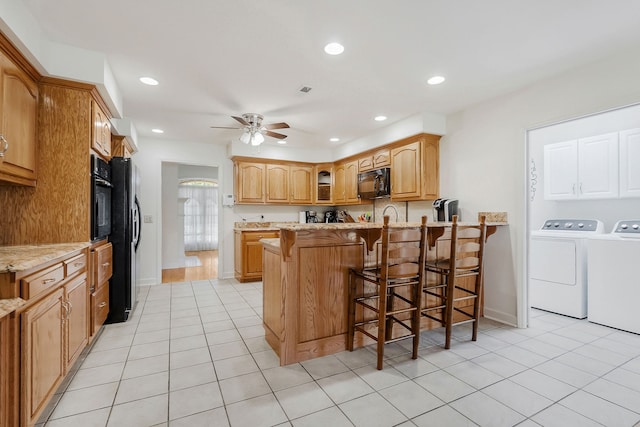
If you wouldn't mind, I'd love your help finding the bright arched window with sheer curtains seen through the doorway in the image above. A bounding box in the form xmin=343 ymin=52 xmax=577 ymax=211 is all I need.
xmin=178 ymin=179 xmax=218 ymax=251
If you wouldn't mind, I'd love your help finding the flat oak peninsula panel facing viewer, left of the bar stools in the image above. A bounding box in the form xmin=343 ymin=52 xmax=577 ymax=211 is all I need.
xmin=298 ymin=244 xmax=363 ymax=343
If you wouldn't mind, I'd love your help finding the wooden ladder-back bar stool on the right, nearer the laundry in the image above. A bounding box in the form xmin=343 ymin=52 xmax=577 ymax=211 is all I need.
xmin=421 ymin=215 xmax=486 ymax=349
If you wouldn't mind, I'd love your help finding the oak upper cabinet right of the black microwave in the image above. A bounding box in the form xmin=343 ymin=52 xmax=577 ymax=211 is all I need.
xmin=391 ymin=134 xmax=440 ymax=201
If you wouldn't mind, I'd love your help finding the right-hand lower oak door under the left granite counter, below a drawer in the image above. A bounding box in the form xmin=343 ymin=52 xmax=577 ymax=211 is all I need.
xmin=64 ymin=275 xmax=89 ymax=366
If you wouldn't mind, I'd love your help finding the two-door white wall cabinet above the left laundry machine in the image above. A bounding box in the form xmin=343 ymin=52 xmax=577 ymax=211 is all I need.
xmin=544 ymin=132 xmax=618 ymax=200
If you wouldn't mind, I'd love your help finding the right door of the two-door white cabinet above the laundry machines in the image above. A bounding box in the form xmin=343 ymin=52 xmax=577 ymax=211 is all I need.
xmin=578 ymin=132 xmax=618 ymax=199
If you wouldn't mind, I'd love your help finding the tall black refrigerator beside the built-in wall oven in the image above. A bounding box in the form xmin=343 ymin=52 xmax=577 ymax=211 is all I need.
xmin=106 ymin=157 xmax=142 ymax=323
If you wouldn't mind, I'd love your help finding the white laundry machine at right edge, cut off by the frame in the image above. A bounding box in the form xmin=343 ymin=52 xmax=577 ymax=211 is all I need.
xmin=588 ymin=220 xmax=640 ymax=334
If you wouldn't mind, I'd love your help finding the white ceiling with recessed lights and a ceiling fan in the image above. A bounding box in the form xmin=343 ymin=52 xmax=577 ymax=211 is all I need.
xmin=24 ymin=0 xmax=640 ymax=148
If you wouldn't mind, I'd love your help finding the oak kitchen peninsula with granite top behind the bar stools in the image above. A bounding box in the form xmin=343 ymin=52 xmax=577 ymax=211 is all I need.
xmin=261 ymin=222 xmax=506 ymax=365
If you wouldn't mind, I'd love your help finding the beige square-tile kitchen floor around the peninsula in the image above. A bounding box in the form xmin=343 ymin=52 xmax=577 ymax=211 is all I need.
xmin=39 ymin=280 xmax=640 ymax=427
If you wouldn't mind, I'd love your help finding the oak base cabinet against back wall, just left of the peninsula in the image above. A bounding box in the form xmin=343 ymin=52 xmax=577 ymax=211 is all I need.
xmin=234 ymin=230 xmax=280 ymax=282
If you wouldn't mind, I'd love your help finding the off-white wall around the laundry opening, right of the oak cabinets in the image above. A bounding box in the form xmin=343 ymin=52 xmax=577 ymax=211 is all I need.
xmin=440 ymin=44 xmax=640 ymax=326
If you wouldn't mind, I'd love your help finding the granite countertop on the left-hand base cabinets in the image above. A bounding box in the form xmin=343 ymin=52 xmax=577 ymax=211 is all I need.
xmin=0 ymin=242 xmax=90 ymax=273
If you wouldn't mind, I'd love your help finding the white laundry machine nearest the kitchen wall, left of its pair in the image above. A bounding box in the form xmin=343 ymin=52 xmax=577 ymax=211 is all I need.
xmin=529 ymin=219 xmax=604 ymax=319
